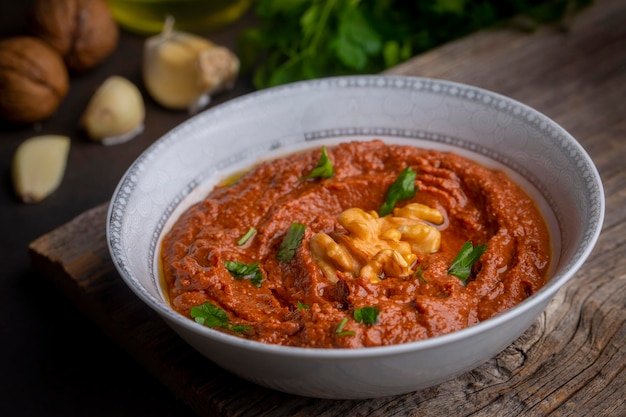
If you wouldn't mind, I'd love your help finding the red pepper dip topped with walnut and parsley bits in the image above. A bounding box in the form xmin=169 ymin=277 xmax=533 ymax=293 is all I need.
xmin=161 ymin=140 xmax=550 ymax=348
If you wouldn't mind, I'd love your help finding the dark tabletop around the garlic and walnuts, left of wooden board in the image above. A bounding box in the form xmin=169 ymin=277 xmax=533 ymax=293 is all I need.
xmin=0 ymin=0 xmax=252 ymax=416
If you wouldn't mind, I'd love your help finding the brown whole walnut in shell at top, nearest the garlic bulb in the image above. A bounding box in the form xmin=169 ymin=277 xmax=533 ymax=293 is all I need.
xmin=29 ymin=0 xmax=119 ymax=72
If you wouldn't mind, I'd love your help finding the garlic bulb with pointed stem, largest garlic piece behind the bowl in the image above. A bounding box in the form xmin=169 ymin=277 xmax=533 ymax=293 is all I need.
xmin=143 ymin=17 xmax=239 ymax=114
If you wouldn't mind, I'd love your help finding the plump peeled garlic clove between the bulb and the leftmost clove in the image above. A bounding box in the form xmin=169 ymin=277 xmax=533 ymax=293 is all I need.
xmin=81 ymin=75 xmax=145 ymax=145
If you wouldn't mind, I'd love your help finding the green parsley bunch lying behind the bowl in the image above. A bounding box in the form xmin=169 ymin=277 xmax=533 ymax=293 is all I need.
xmin=238 ymin=0 xmax=593 ymax=88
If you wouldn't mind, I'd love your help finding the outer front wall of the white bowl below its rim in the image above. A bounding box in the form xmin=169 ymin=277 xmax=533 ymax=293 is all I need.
xmin=162 ymin=294 xmax=548 ymax=399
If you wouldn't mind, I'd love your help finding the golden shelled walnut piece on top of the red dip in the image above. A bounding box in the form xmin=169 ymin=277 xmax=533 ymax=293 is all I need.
xmin=309 ymin=203 xmax=444 ymax=282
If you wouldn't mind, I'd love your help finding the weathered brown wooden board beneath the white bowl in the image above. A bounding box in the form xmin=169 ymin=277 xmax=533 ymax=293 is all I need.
xmin=30 ymin=0 xmax=626 ymax=417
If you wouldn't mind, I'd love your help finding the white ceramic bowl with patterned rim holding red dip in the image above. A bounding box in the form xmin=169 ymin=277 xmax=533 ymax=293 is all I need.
xmin=107 ymin=76 xmax=604 ymax=399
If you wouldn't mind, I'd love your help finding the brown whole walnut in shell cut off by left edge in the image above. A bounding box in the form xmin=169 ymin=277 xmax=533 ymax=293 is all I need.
xmin=0 ymin=36 xmax=69 ymax=123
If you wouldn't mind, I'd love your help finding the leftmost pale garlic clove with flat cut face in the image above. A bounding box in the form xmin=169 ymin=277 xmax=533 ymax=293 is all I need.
xmin=12 ymin=135 xmax=70 ymax=203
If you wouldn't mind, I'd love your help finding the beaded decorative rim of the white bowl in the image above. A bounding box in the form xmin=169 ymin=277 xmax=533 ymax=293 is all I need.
xmin=106 ymin=74 xmax=605 ymax=360
